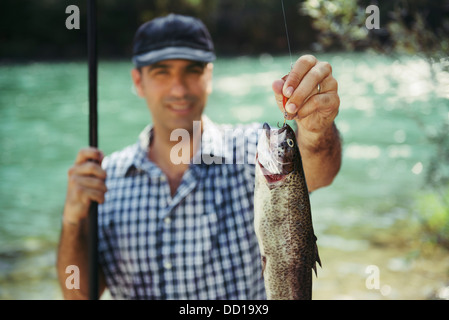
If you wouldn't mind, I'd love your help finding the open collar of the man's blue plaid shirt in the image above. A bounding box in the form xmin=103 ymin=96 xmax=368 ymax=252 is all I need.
xmin=122 ymin=115 xmax=232 ymax=175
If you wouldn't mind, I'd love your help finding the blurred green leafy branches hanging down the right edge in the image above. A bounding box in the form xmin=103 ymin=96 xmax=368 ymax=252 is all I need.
xmin=301 ymin=0 xmax=449 ymax=249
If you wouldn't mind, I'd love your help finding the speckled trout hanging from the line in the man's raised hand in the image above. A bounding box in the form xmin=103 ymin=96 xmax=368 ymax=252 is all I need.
xmin=254 ymin=123 xmax=321 ymax=300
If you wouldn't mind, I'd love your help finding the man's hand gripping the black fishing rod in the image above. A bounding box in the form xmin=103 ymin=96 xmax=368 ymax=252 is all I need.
xmin=63 ymin=147 xmax=107 ymax=224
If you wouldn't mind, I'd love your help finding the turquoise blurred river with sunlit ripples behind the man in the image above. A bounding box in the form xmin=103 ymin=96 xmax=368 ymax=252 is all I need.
xmin=0 ymin=53 xmax=449 ymax=299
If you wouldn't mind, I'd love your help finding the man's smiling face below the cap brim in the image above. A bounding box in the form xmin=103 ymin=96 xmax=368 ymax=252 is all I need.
xmin=132 ymin=60 xmax=213 ymax=132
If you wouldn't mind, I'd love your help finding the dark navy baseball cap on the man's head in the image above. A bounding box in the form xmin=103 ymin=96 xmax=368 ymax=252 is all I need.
xmin=132 ymin=14 xmax=216 ymax=67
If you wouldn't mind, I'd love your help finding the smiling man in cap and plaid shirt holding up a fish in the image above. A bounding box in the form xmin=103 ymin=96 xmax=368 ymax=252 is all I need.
xmin=57 ymin=14 xmax=341 ymax=299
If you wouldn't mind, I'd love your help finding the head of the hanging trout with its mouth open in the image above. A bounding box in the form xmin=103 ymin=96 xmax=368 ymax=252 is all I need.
xmin=256 ymin=123 xmax=301 ymax=184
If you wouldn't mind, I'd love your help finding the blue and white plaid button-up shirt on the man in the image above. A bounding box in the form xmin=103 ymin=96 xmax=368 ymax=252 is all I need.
xmin=98 ymin=117 xmax=266 ymax=299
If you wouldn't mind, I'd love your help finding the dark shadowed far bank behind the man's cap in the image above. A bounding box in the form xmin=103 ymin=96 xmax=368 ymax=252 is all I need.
xmin=0 ymin=0 xmax=316 ymax=61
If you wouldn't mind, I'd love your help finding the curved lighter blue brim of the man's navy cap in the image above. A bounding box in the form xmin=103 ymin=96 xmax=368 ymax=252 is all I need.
xmin=132 ymin=47 xmax=216 ymax=67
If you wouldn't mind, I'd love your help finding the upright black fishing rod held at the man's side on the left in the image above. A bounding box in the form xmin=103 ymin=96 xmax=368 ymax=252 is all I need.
xmin=87 ymin=0 xmax=99 ymax=300
